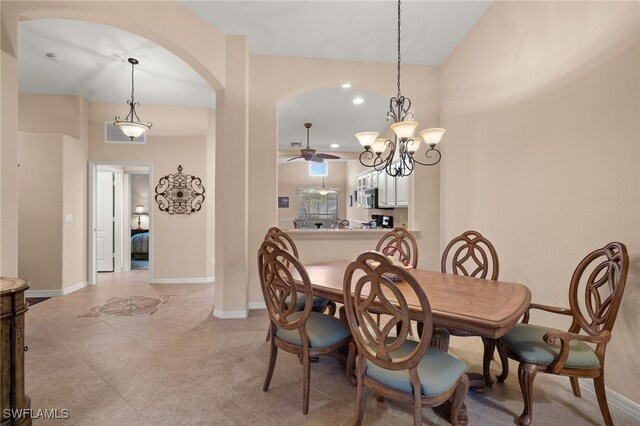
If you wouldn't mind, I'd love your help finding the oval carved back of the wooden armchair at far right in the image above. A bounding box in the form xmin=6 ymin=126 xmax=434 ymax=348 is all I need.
xmin=569 ymin=242 xmax=629 ymax=336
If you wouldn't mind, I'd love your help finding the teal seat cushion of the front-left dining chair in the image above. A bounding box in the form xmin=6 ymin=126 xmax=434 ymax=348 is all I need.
xmin=276 ymin=312 xmax=351 ymax=348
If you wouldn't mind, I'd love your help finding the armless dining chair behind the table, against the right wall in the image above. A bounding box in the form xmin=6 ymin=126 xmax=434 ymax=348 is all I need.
xmin=434 ymin=231 xmax=500 ymax=389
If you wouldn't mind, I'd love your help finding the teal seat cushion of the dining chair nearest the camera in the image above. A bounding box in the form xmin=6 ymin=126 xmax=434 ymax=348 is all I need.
xmin=365 ymin=340 xmax=465 ymax=397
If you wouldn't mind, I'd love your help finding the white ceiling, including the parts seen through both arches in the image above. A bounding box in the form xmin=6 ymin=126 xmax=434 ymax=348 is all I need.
xmin=19 ymin=0 xmax=490 ymax=152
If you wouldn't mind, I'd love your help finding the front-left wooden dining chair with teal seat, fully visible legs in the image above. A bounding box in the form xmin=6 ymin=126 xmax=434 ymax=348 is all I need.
xmin=258 ymin=241 xmax=355 ymax=414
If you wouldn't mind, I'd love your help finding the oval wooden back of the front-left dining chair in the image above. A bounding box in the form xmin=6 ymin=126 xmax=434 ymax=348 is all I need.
xmin=258 ymin=241 xmax=313 ymax=332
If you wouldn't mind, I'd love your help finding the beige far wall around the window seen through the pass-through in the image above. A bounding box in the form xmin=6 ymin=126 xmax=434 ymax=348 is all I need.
xmin=278 ymin=161 xmax=347 ymax=229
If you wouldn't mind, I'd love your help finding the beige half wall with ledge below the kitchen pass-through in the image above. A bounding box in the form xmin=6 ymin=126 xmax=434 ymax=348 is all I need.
xmin=285 ymin=228 xmax=420 ymax=263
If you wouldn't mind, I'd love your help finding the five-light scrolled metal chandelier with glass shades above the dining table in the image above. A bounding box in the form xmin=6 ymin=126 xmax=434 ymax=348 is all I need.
xmin=356 ymin=0 xmax=445 ymax=177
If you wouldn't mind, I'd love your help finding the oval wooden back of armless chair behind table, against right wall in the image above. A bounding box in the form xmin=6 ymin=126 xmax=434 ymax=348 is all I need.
xmin=440 ymin=231 xmax=500 ymax=280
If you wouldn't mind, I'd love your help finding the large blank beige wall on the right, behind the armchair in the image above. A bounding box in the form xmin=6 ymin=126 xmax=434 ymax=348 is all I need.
xmin=440 ymin=2 xmax=640 ymax=403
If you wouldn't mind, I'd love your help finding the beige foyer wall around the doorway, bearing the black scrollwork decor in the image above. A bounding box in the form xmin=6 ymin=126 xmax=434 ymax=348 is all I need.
xmin=89 ymin=103 xmax=215 ymax=280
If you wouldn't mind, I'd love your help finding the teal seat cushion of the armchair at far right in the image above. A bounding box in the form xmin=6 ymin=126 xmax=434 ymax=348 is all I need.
xmin=500 ymin=324 xmax=600 ymax=368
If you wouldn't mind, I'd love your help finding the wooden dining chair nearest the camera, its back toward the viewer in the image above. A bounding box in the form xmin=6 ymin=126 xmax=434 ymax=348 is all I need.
xmin=343 ymin=251 xmax=469 ymax=425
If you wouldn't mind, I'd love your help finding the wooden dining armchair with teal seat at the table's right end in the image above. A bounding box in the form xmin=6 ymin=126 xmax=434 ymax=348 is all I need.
xmin=498 ymin=242 xmax=629 ymax=426
